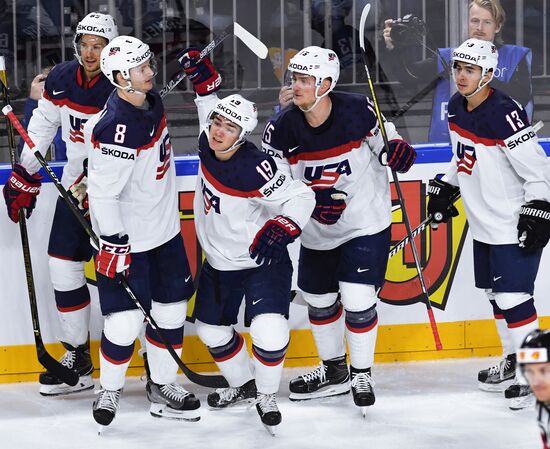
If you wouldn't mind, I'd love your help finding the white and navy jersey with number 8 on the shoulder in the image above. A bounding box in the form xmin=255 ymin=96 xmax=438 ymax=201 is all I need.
xmin=84 ymin=91 xmax=180 ymax=252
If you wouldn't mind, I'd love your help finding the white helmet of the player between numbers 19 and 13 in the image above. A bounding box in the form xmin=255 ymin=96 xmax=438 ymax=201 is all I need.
xmin=288 ymin=46 xmax=340 ymax=112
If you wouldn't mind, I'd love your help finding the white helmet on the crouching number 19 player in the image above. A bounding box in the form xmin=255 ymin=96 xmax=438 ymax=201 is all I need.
xmin=207 ymin=94 xmax=258 ymax=152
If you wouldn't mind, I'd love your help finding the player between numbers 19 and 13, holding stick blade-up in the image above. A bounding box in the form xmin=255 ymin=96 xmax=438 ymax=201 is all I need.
xmin=263 ymin=47 xmax=416 ymax=412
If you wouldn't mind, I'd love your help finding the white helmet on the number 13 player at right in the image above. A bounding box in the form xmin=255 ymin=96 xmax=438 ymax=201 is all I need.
xmin=452 ymin=38 xmax=498 ymax=97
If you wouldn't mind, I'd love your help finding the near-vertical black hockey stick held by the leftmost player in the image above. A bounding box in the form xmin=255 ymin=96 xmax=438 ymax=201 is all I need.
xmin=0 ymin=56 xmax=79 ymax=387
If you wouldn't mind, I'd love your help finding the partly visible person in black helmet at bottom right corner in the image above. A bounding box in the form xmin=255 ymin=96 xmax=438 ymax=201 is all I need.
xmin=518 ymin=329 xmax=550 ymax=449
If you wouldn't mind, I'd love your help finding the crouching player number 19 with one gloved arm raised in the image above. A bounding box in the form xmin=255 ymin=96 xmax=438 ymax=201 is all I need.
xmin=180 ymin=49 xmax=315 ymax=432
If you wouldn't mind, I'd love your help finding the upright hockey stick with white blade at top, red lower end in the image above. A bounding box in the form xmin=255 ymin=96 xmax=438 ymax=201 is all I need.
xmin=359 ymin=3 xmax=443 ymax=351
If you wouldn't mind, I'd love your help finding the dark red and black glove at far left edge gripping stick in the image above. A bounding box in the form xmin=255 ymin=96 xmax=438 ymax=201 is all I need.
xmin=4 ymin=164 xmax=42 ymax=223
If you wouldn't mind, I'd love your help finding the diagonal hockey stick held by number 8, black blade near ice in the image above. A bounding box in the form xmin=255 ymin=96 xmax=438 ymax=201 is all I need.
xmin=2 ymin=101 xmax=228 ymax=388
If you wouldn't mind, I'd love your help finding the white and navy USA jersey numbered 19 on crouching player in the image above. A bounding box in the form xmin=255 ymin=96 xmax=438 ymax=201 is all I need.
xmin=193 ymin=94 xmax=315 ymax=271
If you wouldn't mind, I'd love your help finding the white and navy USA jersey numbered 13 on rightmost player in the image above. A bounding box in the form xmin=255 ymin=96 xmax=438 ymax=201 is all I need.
xmin=443 ymin=90 xmax=550 ymax=245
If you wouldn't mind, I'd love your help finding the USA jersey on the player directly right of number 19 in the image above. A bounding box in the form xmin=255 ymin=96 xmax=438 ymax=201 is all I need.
xmin=262 ymin=92 xmax=401 ymax=250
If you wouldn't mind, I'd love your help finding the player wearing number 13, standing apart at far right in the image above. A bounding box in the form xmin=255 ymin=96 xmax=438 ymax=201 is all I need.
xmin=428 ymin=39 xmax=550 ymax=409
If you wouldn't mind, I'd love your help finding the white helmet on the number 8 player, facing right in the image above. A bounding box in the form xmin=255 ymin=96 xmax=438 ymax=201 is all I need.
xmin=101 ymin=36 xmax=156 ymax=92
